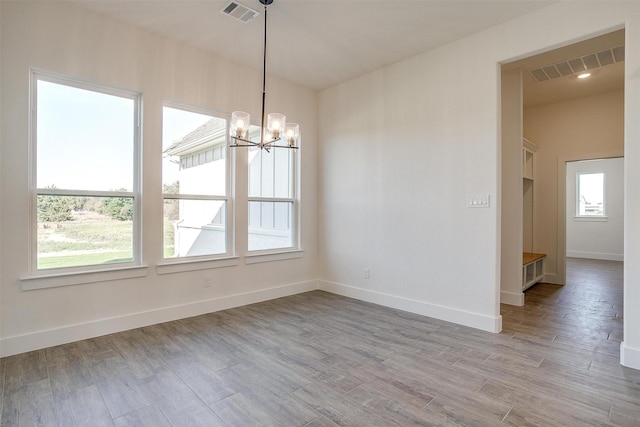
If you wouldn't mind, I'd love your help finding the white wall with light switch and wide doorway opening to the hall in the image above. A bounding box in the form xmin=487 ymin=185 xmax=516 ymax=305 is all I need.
xmin=319 ymin=2 xmax=640 ymax=367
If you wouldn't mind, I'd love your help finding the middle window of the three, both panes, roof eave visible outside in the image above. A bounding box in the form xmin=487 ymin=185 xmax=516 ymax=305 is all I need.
xmin=162 ymin=106 xmax=230 ymax=259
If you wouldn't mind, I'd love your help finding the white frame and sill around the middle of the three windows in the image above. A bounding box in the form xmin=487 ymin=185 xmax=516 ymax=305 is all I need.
xmin=157 ymin=100 xmax=238 ymax=274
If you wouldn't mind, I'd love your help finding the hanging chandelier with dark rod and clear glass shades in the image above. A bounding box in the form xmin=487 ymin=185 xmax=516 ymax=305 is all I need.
xmin=229 ymin=0 xmax=300 ymax=151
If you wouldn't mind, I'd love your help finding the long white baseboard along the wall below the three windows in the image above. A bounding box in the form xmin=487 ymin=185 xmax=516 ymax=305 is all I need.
xmin=0 ymin=280 xmax=318 ymax=357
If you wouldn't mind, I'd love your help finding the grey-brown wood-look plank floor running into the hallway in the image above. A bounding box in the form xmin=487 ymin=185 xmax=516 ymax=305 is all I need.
xmin=0 ymin=259 xmax=640 ymax=427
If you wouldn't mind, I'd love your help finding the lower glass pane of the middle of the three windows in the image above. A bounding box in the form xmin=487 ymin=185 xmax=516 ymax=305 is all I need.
xmin=164 ymin=198 xmax=227 ymax=258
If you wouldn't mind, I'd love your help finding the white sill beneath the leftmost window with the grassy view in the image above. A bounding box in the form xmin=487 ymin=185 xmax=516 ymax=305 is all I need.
xmin=20 ymin=265 xmax=148 ymax=291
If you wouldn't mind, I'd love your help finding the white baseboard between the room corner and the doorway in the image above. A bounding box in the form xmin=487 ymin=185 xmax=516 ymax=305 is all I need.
xmin=318 ymin=280 xmax=502 ymax=332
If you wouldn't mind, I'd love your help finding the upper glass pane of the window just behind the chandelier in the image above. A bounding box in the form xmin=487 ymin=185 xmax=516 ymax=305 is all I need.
xmin=249 ymin=147 xmax=293 ymax=198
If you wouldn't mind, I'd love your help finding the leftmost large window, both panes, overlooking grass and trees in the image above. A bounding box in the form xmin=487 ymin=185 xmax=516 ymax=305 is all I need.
xmin=31 ymin=72 xmax=141 ymax=271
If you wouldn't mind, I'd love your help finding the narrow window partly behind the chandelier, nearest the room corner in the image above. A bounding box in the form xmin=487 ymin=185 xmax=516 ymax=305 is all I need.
xmin=248 ymin=129 xmax=297 ymax=251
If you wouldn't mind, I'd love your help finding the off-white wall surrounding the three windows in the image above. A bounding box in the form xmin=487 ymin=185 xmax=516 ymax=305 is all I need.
xmin=0 ymin=1 xmax=318 ymax=356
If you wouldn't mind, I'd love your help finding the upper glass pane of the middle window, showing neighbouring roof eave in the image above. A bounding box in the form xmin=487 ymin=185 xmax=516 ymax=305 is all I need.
xmin=162 ymin=107 xmax=227 ymax=196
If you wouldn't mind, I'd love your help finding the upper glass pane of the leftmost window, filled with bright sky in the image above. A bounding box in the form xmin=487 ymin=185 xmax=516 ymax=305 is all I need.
xmin=36 ymin=80 xmax=136 ymax=191
